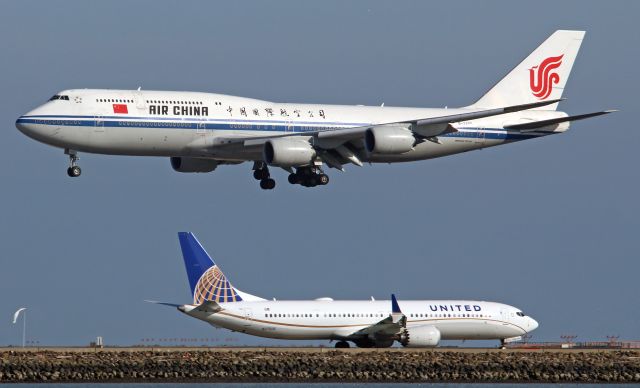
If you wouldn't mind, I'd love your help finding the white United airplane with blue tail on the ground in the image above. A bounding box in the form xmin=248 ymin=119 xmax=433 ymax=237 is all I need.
xmin=147 ymin=232 xmax=538 ymax=348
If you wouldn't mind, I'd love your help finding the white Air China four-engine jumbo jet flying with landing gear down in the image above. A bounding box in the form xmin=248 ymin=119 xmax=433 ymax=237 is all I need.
xmin=16 ymin=30 xmax=612 ymax=190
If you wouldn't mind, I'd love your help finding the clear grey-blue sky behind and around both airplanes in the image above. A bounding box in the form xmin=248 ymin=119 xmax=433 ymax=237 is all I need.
xmin=0 ymin=0 xmax=640 ymax=346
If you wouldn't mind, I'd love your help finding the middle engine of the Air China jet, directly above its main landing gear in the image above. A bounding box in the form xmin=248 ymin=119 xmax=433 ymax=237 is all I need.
xmin=262 ymin=137 xmax=316 ymax=167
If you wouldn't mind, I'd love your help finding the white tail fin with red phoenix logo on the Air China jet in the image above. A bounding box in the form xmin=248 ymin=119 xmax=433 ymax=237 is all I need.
xmin=472 ymin=30 xmax=585 ymax=110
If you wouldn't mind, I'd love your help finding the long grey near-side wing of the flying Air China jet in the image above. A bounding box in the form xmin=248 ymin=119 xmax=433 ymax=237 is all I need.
xmin=212 ymin=99 xmax=561 ymax=169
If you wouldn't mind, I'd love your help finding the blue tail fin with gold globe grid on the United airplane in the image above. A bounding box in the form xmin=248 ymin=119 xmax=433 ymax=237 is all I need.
xmin=178 ymin=232 xmax=262 ymax=305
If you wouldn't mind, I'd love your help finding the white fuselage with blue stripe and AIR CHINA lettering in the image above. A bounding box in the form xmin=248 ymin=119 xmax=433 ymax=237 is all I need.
xmin=16 ymin=89 xmax=568 ymax=163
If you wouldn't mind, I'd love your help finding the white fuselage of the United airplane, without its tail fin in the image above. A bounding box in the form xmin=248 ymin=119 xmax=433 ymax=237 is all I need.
xmin=183 ymin=300 xmax=538 ymax=340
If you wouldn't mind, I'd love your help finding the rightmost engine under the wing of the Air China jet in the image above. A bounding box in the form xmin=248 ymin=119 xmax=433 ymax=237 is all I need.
xmin=364 ymin=126 xmax=416 ymax=154
